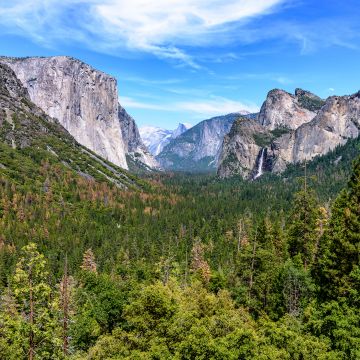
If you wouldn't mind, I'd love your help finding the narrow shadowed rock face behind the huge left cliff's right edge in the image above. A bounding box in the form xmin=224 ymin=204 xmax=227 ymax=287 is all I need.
xmin=118 ymin=104 xmax=159 ymax=169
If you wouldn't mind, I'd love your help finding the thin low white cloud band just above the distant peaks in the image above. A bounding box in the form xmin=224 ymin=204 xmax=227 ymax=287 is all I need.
xmin=119 ymin=96 xmax=259 ymax=119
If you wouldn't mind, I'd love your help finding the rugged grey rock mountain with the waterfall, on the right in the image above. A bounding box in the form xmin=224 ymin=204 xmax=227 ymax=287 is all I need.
xmin=218 ymin=89 xmax=360 ymax=178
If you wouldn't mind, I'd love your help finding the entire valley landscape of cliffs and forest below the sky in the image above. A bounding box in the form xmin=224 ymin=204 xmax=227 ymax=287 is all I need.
xmin=0 ymin=57 xmax=360 ymax=360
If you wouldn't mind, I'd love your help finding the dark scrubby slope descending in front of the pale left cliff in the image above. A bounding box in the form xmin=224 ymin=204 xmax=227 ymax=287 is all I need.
xmin=0 ymin=63 xmax=141 ymax=190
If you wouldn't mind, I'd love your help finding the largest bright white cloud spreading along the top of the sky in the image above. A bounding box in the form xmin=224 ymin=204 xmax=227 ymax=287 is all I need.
xmin=0 ymin=0 xmax=285 ymax=68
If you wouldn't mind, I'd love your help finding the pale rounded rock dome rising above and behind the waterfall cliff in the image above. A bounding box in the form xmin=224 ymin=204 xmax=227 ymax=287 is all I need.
xmin=258 ymin=89 xmax=316 ymax=130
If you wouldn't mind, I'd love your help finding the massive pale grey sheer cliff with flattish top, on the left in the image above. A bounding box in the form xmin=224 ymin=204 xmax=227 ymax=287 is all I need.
xmin=0 ymin=56 xmax=155 ymax=169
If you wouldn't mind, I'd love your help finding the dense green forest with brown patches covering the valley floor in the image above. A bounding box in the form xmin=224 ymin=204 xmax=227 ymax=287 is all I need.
xmin=0 ymin=134 xmax=360 ymax=360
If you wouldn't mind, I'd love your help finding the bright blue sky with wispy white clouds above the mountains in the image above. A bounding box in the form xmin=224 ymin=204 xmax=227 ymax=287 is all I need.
xmin=0 ymin=0 xmax=360 ymax=129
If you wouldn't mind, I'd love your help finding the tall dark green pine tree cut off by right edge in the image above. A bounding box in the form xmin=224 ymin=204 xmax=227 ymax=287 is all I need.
xmin=315 ymin=158 xmax=360 ymax=305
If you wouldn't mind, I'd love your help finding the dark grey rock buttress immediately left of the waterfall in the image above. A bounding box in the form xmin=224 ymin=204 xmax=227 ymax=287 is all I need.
xmin=218 ymin=118 xmax=270 ymax=178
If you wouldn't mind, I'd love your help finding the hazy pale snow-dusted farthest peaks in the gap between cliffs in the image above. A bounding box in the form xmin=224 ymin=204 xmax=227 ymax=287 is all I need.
xmin=140 ymin=123 xmax=191 ymax=156
